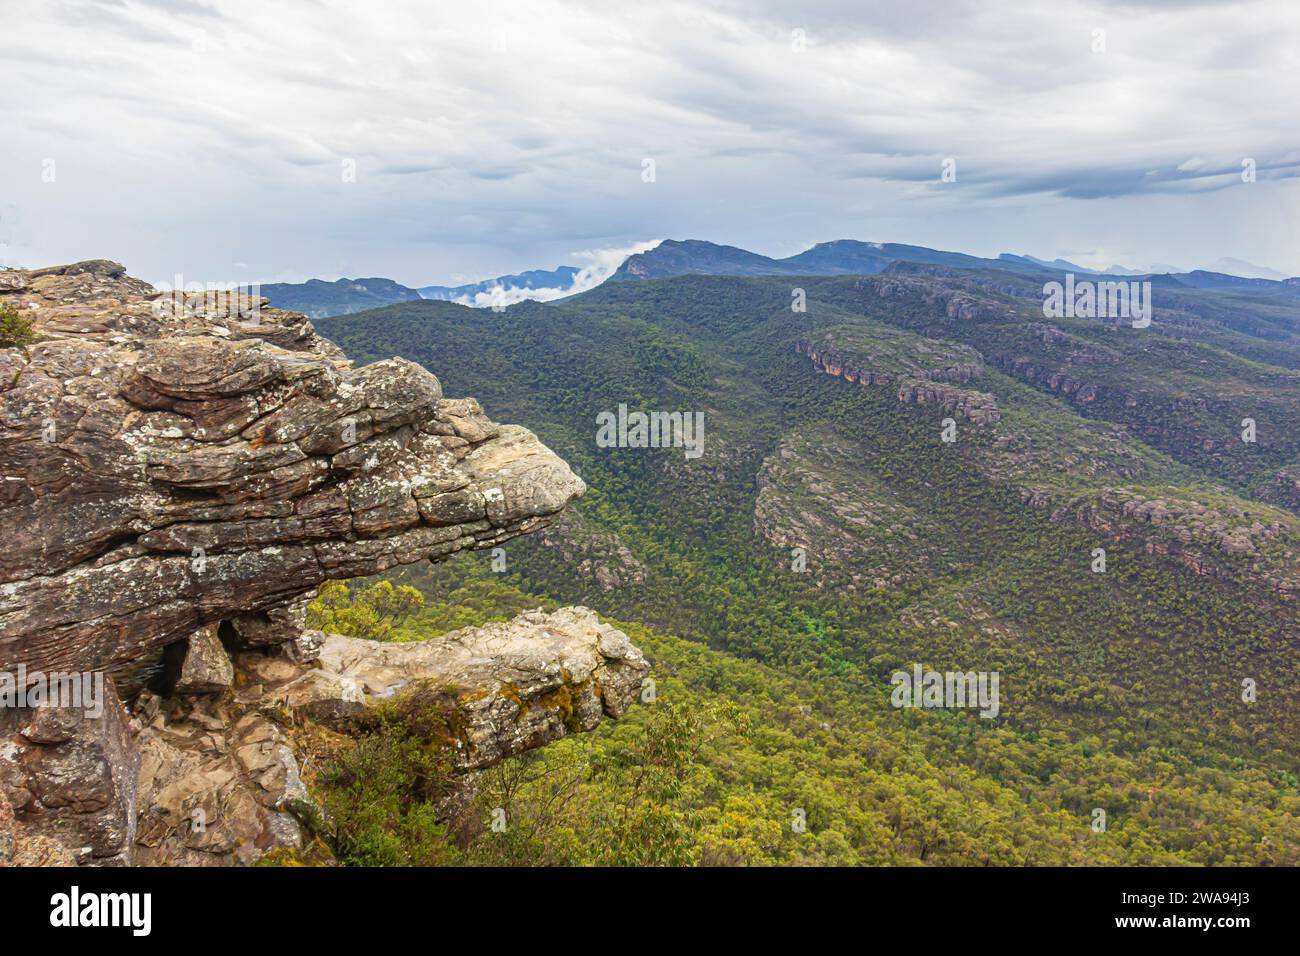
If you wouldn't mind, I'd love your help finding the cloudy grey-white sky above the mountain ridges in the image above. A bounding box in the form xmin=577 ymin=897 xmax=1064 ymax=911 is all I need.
xmin=0 ymin=0 xmax=1300 ymax=285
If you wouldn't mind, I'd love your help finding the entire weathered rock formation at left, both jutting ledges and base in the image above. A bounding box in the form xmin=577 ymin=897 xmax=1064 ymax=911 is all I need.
xmin=0 ymin=260 xmax=645 ymax=864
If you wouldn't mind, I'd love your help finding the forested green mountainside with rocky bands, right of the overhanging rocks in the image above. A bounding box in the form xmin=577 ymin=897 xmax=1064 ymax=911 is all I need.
xmin=319 ymin=265 xmax=1300 ymax=864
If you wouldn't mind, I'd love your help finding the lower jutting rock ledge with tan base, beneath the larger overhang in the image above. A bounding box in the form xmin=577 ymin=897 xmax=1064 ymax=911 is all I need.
xmin=124 ymin=607 xmax=649 ymax=866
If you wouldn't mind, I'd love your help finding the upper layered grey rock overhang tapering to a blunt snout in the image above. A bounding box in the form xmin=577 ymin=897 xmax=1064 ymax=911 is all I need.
xmin=0 ymin=261 xmax=584 ymax=671
